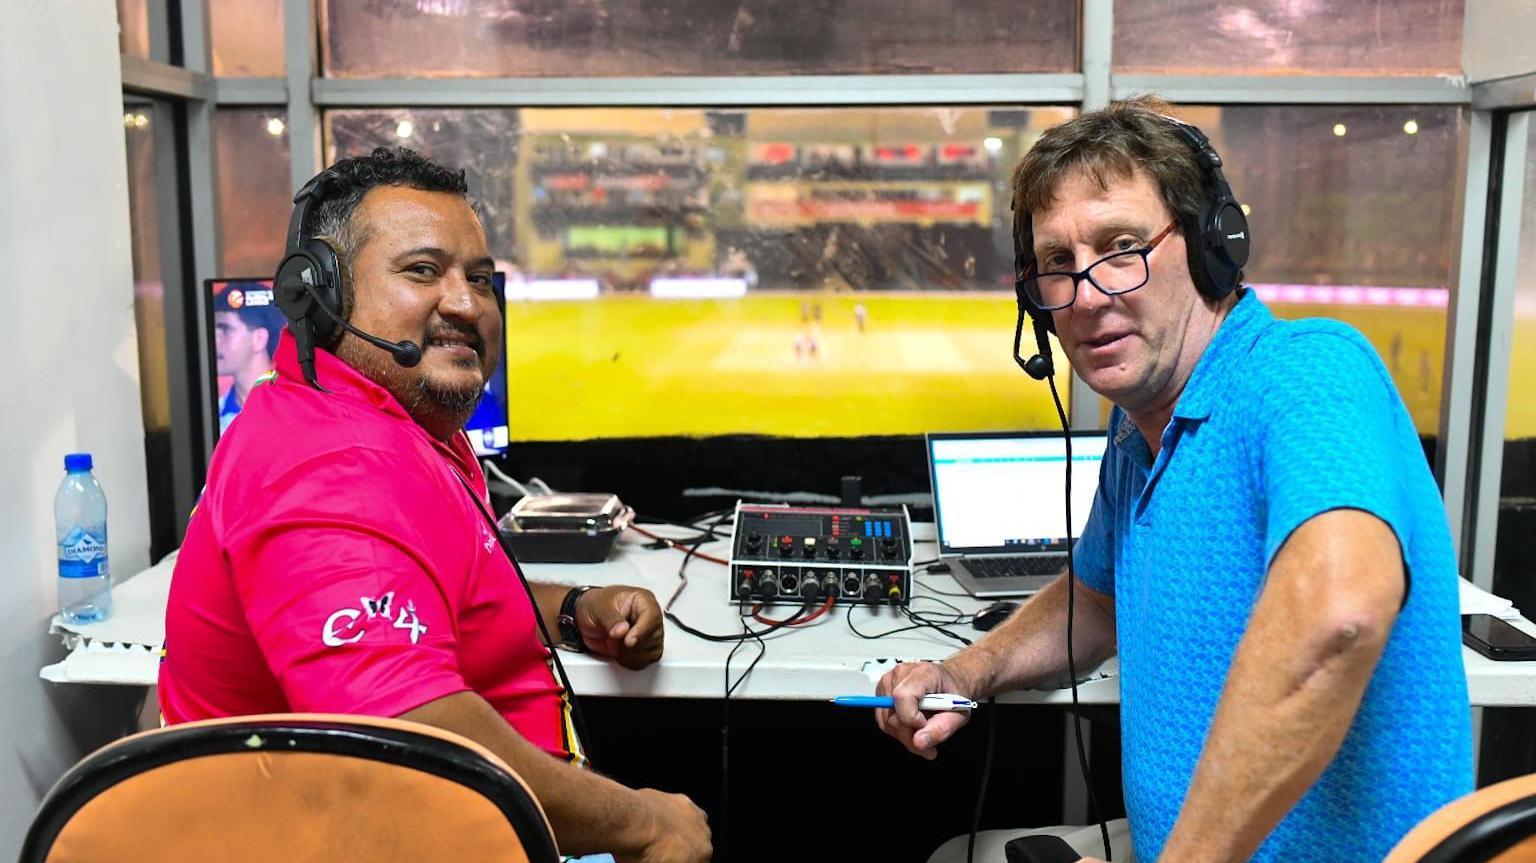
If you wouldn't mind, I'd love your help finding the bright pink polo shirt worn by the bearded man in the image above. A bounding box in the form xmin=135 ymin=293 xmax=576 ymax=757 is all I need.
xmin=160 ymin=330 xmax=581 ymax=760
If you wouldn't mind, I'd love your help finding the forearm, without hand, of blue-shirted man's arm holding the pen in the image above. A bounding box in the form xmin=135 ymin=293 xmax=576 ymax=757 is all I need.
xmin=945 ymin=576 xmax=1115 ymax=697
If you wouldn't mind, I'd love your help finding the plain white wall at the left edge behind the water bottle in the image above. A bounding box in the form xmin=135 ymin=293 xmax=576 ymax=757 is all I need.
xmin=0 ymin=0 xmax=149 ymax=860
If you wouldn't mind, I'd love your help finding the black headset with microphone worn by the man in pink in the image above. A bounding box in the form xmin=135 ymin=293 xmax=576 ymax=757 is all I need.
xmin=272 ymin=167 xmax=421 ymax=390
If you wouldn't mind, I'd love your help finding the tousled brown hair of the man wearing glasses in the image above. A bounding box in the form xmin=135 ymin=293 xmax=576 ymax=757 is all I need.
xmin=1014 ymin=95 xmax=1212 ymax=256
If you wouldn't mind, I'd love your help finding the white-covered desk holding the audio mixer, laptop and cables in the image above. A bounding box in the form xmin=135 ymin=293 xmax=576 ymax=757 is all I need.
xmin=41 ymin=533 xmax=1536 ymax=706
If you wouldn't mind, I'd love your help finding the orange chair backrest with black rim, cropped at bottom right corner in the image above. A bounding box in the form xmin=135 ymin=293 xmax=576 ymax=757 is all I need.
xmin=1384 ymin=775 xmax=1536 ymax=863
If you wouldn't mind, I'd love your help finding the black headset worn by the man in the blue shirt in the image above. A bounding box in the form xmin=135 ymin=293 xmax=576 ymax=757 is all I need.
xmin=1012 ymin=117 xmax=1252 ymax=381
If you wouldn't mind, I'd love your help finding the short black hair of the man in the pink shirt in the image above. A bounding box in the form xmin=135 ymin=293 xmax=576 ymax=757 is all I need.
xmin=304 ymin=147 xmax=470 ymax=272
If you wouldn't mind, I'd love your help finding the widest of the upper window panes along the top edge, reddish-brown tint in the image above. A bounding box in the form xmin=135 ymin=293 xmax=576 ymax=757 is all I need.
xmin=321 ymin=0 xmax=1078 ymax=78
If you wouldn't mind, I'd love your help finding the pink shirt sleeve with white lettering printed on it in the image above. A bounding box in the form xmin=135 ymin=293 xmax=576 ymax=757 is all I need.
xmin=227 ymin=450 xmax=470 ymax=716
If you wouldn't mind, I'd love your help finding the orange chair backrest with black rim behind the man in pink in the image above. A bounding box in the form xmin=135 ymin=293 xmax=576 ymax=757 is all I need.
xmin=20 ymin=714 xmax=559 ymax=863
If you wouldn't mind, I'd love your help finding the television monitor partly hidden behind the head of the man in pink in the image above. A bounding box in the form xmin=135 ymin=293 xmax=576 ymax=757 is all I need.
xmin=204 ymin=272 xmax=508 ymax=456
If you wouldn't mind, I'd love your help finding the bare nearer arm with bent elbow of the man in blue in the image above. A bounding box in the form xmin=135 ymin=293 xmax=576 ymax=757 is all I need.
xmin=1163 ymin=513 xmax=1402 ymax=863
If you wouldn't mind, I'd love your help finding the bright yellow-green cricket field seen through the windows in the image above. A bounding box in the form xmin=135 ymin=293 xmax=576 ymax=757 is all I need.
xmin=507 ymin=292 xmax=1536 ymax=441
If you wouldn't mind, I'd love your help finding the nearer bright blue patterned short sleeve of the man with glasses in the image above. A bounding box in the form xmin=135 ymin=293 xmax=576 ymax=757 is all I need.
xmin=1258 ymin=326 xmax=1422 ymax=570
